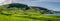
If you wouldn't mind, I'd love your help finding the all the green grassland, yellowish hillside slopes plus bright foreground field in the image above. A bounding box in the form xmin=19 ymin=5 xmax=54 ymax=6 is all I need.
xmin=0 ymin=6 xmax=60 ymax=21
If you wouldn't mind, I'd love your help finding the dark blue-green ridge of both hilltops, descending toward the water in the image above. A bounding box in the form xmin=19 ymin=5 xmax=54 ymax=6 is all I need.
xmin=0 ymin=3 xmax=60 ymax=14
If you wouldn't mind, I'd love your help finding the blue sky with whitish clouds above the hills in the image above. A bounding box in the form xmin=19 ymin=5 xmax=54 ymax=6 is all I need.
xmin=0 ymin=0 xmax=60 ymax=11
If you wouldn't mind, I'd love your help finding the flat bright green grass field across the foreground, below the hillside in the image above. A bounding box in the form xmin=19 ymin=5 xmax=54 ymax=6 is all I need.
xmin=0 ymin=14 xmax=60 ymax=21
